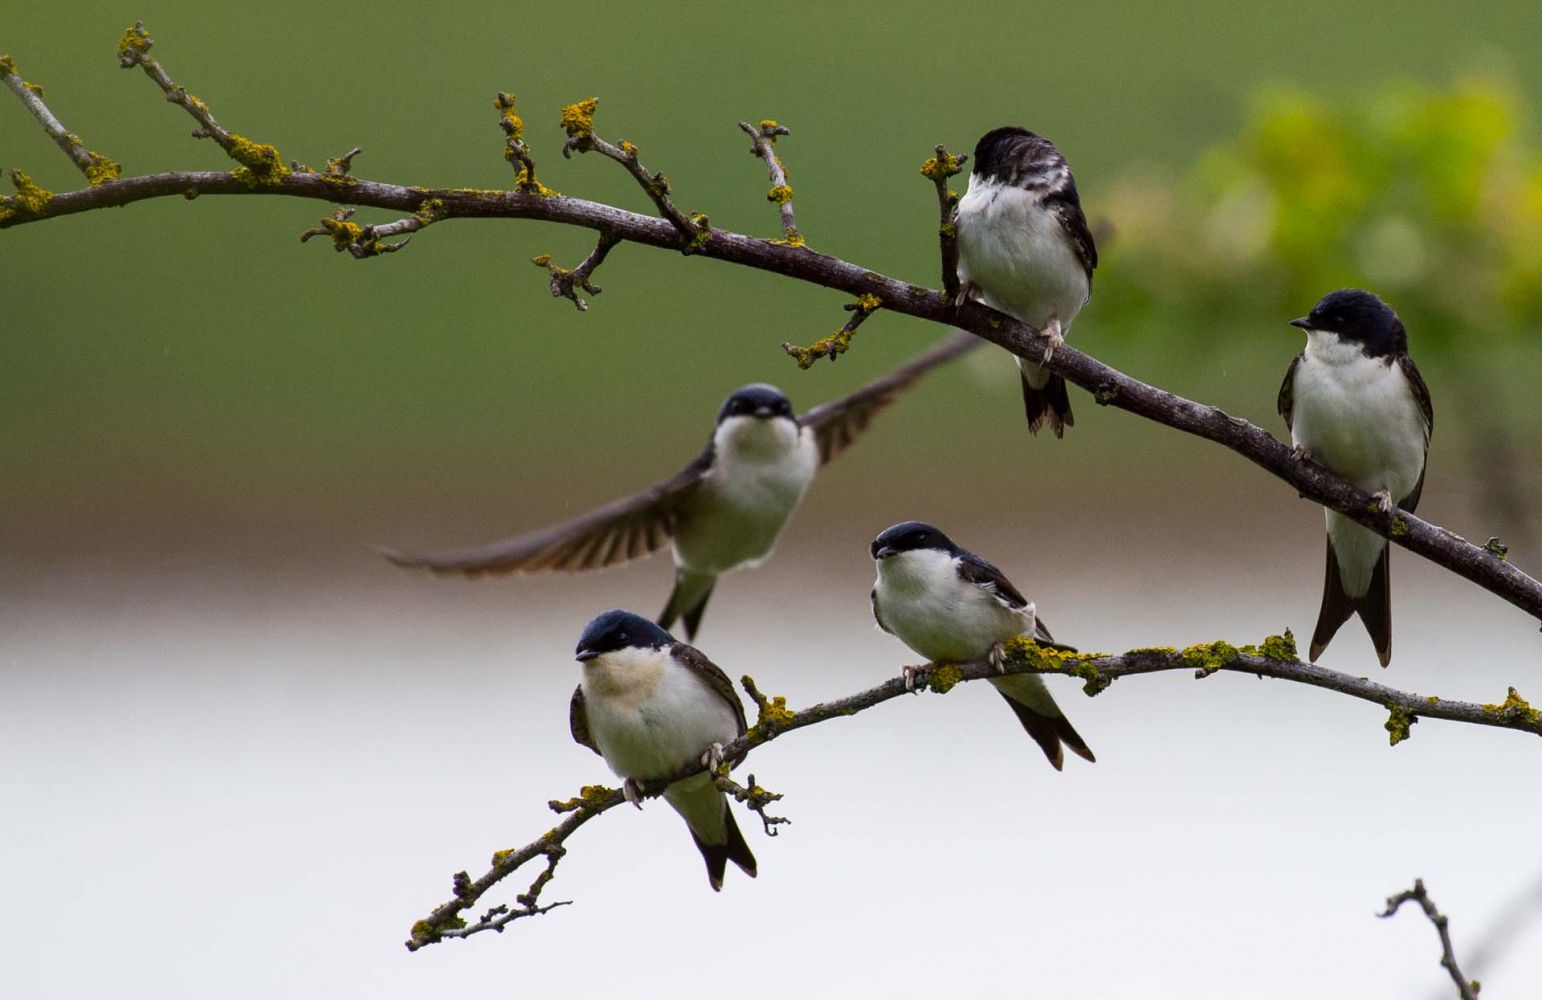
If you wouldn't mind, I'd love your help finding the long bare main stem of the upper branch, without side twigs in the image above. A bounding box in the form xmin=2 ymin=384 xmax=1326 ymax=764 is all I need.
xmin=0 ymin=171 xmax=1542 ymax=619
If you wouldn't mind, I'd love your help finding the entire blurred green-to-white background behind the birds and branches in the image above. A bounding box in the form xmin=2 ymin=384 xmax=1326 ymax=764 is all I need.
xmin=0 ymin=0 xmax=1542 ymax=1000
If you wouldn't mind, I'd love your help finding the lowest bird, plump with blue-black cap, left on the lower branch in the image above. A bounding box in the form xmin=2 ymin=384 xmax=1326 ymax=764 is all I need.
xmin=567 ymin=609 xmax=756 ymax=892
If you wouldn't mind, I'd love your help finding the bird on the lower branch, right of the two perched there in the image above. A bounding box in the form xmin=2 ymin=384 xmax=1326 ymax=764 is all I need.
xmin=870 ymin=521 xmax=1096 ymax=770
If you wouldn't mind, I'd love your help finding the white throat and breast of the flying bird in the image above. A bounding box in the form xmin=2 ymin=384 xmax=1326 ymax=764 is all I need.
xmin=674 ymin=416 xmax=819 ymax=573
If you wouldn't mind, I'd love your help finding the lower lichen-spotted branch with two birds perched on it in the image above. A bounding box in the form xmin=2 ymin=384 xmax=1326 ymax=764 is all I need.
xmin=406 ymin=632 xmax=1542 ymax=951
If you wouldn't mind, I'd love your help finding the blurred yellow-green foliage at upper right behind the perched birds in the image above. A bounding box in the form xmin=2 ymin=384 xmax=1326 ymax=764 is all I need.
xmin=1096 ymin=77 xmax=1542 ymax=354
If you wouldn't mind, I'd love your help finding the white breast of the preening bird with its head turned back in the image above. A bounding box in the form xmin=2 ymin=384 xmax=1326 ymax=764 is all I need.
xmin=958 ymin=176 xmax=1092 ymax=333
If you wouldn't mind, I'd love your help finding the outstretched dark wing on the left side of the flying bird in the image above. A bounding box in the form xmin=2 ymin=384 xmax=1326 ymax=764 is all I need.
xmin=378 ymin=445 xmax=712 ymax=576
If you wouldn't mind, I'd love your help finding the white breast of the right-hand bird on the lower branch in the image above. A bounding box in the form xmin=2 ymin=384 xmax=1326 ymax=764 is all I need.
xmin=873 ymin=549 xmax=1033 ymax=663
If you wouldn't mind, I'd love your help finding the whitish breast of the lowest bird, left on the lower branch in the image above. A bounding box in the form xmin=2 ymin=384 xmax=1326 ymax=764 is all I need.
xmin=580 ymin=649 xmax=739 ymax=781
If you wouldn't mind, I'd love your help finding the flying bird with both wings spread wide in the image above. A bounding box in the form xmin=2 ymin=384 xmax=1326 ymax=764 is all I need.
xmin=376 ymin=333 xmax=979 ymax=639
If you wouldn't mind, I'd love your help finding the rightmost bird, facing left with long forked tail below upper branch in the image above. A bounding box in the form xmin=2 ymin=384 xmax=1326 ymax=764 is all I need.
xmin=1278 ymin=288 xmax=1436 ymax=667
